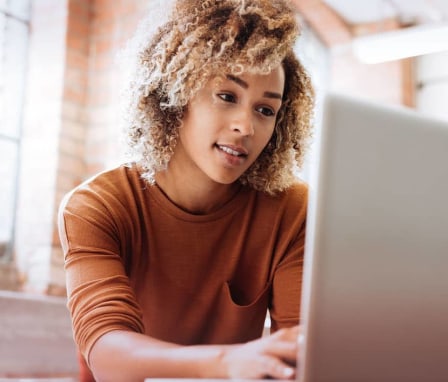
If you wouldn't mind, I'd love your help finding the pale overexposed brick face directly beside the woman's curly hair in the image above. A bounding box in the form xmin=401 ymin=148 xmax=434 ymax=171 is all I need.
xmin=86 ymin=0 xmax=151 ymax=175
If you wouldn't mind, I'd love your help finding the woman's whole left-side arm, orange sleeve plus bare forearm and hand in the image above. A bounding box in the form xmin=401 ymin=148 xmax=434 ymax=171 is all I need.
xmin=59 ymin=184 xmax=297 ymax=381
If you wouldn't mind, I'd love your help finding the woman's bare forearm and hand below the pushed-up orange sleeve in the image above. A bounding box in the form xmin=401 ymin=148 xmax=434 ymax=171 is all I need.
xmin=89 ymin=327 xmax=298 ymax=381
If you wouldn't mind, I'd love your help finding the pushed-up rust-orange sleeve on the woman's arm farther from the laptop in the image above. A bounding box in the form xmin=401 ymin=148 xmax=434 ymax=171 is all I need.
xmin=58 ymin=186 xmax=144 ymax=362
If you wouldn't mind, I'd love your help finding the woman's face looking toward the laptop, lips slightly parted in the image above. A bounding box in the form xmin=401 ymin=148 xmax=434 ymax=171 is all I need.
xmin=172 ymin=66 xmax=285 ymax=188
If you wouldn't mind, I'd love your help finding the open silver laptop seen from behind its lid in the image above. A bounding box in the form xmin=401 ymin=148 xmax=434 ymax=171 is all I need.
xmin=298 ymin=94 xmax=448 ymax=382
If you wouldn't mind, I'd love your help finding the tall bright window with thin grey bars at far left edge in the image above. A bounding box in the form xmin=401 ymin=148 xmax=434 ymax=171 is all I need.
xmin=0 ymin=0 xmax=30 ymax=262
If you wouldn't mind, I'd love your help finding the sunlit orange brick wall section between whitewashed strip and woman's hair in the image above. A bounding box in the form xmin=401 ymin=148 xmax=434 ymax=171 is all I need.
xmin=49 ymin=0 xmax=150 ymax=294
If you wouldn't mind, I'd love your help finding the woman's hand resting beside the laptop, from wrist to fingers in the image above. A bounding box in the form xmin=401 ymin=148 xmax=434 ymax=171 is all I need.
xmin=223 ymin=326 xmax=300 ymax=379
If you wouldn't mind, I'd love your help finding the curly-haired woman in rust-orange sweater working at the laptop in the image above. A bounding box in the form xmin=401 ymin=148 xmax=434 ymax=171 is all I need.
xmin=59 ymin=0 xmax=313 ymax=381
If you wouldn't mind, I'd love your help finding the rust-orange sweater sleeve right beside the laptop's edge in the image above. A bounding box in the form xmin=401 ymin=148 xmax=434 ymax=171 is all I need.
xmin=270 ymin=187 xmax=307 ymax=332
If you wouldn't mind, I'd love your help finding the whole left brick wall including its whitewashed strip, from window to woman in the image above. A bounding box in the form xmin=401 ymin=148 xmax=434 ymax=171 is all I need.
xmin=12 ymin=0 xmax=151 ymax=295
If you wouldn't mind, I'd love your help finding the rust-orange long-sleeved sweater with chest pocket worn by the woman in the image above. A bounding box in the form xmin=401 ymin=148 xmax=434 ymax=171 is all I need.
xmin=59 ymin=165 xmax=307 ymax=359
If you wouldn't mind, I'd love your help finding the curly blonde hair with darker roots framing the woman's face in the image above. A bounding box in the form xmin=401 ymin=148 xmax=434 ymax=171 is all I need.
xmin=127 ymin=0 xmax=314 ymax=194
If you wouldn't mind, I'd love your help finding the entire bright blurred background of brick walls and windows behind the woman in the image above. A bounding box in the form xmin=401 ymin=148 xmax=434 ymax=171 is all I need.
xmin=0 ymin=0 xmax=448 ymax=377
